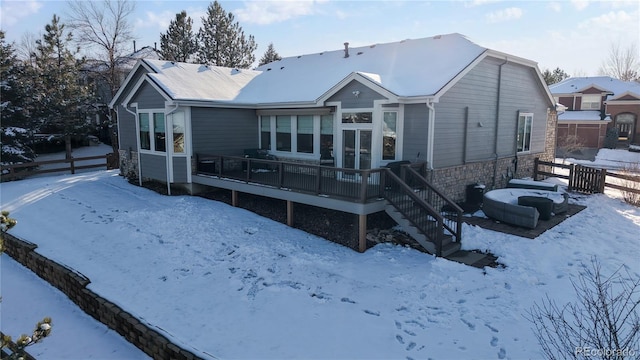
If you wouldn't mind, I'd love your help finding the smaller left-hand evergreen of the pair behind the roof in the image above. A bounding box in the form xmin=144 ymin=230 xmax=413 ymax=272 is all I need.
xmin=160 ymin=10 xmax=198 ymax=62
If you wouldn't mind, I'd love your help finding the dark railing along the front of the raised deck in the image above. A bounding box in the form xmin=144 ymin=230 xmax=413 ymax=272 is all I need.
xmin=196 ymin=154 xmax=386 ymax=203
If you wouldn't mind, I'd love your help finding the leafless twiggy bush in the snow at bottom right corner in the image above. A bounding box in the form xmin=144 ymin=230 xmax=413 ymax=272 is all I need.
xmin=525 ymin=257 xmax=640 ymax=359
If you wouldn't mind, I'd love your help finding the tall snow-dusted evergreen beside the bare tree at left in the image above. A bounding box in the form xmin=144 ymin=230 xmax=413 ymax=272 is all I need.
xmin=34 ymin=14 xmax=95 ymax=158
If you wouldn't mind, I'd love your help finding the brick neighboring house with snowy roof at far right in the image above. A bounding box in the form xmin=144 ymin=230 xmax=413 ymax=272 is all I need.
xmin=549 ymin=76 xmax=640 ymax=149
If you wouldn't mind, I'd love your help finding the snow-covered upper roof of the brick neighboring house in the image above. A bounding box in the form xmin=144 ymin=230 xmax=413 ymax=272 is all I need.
xmin=549 ymin=76 xmax=640 ymax=100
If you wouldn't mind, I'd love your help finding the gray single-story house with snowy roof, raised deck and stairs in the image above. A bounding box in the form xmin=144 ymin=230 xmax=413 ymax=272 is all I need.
xmin=110 ymin=34 xmax=556 ymax=255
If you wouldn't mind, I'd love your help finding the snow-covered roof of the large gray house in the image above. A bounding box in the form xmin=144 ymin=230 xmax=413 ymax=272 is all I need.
xmin=134 ymin=34 xmax=496 ymax=105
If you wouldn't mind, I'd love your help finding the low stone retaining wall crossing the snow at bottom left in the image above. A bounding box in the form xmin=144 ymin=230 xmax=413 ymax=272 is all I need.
xmin=4 ymin=234 xmax=200 ymax=360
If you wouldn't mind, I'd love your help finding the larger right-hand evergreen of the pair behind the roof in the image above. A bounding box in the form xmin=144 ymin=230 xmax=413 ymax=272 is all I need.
xmin=197 ymin=1 xmax=258 ymax=69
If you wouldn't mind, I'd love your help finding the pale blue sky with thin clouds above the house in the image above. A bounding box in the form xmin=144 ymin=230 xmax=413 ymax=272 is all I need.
xmin=0 ymin=0 xmax=640 ymax=76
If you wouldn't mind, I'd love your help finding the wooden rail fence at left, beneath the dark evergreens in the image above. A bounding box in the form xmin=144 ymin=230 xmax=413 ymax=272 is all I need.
xmin=0 ymin=153 xmax=118 ymax=181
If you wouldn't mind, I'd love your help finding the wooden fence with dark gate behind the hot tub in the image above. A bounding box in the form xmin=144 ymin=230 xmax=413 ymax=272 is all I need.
xmin=533 ymin=158 xmax=640 ymax=194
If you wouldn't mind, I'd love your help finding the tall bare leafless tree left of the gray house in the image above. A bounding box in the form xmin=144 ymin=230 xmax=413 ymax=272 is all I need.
xmin=69 ymin=0 xmax=135 ymax=154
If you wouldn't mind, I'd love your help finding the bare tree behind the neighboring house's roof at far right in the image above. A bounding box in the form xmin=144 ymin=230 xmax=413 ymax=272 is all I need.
xmin=600 ymin=42 xmax=640 ymax=81
